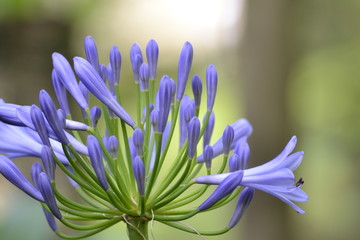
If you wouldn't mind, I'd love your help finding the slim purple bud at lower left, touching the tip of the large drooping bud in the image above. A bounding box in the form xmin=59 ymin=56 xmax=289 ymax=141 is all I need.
xmin=38 ymin=172 xmax=62 ymax=219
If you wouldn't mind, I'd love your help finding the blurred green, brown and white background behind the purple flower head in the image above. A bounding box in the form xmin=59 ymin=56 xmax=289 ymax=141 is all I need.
xmin=0 ymin=0 xmax=360 ymax=240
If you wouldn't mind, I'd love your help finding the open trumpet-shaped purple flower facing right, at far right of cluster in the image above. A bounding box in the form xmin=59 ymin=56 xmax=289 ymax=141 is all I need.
xmin=194 ymin=137 xmax=308 ymax=214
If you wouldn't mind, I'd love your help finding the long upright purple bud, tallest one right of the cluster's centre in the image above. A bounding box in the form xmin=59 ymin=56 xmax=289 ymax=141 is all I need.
xmin=176 ymin=42 xmax=193 ymax=100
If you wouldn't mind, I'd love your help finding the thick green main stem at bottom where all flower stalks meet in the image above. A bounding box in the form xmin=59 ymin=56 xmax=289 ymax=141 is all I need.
xmin=126 ymin=218 xmax=149 ymax=240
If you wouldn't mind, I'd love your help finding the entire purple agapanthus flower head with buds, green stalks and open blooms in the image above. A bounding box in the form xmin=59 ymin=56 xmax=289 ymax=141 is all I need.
xmin=0 ymin=36 xmax=308 ymax=239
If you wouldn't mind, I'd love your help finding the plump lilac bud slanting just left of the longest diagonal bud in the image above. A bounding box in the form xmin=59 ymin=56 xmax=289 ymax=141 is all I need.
xmin=52 ymin=53 xmax=88 ymax=109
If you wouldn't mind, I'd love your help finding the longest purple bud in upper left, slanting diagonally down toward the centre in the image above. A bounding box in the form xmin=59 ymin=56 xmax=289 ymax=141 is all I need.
xmin=74 ymin=57 xmax=136 ymax=127
